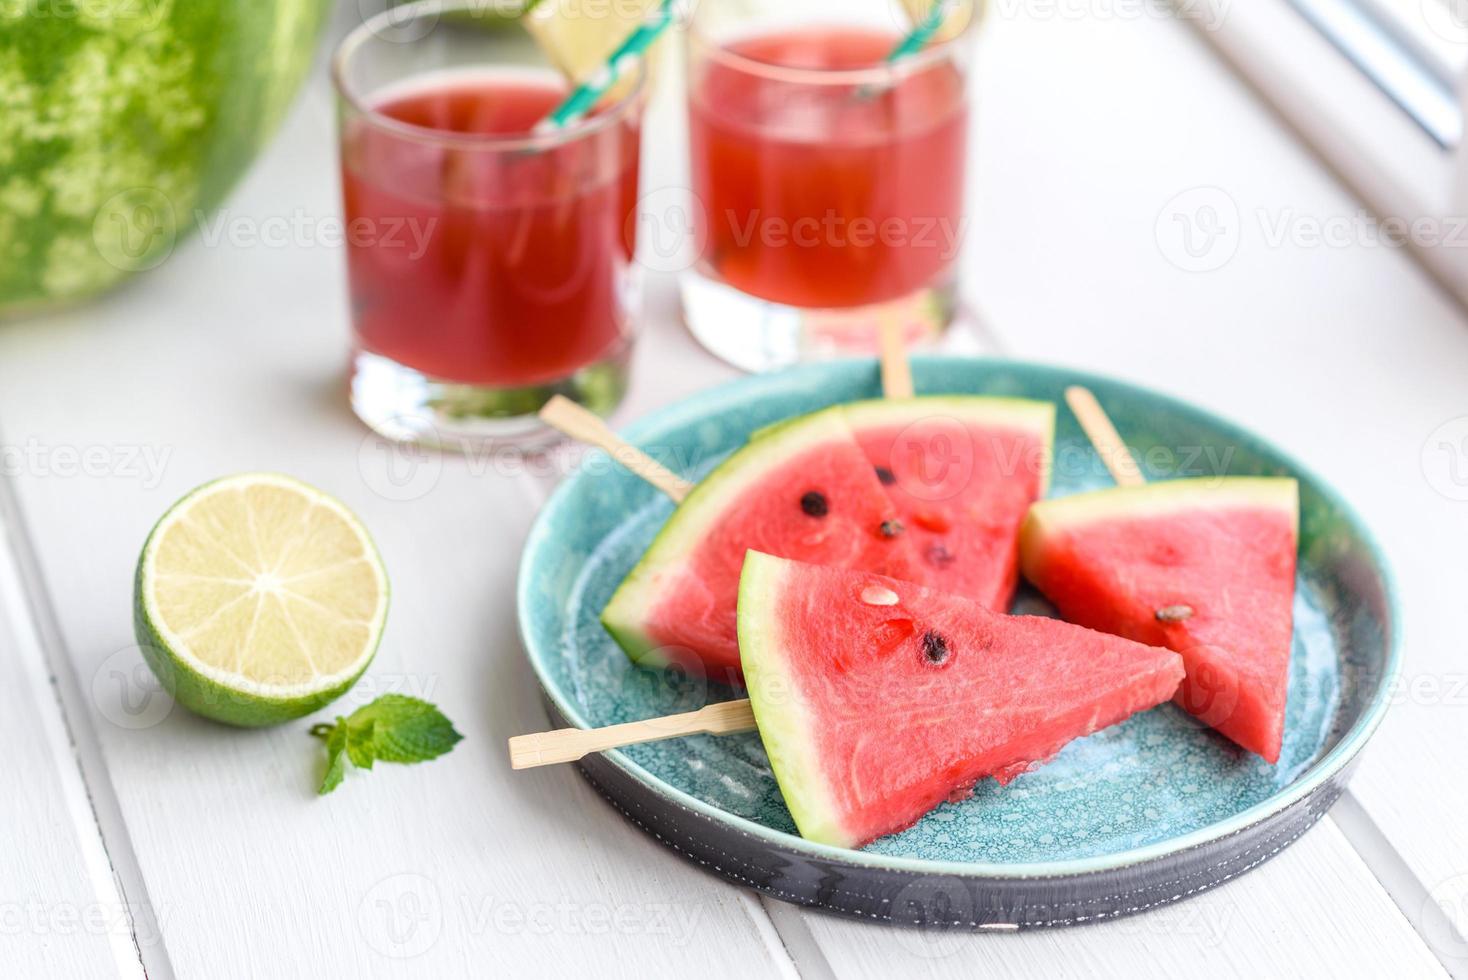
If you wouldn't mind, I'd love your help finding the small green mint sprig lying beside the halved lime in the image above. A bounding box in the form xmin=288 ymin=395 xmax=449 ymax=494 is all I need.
xmin=311 ymin=694 xmax=464 ymax=797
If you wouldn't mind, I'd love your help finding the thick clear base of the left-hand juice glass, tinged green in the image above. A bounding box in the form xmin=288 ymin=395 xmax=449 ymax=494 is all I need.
xmin=351 ymin=343 xmax=631 ymax=452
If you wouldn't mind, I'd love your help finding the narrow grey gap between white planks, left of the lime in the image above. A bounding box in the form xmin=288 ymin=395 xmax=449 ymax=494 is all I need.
xmin=0 ymin=463 xmax=173 ymax=980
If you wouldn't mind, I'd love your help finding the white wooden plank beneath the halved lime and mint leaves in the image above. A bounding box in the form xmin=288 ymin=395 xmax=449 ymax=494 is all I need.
xmin=0 ymin=70 xmax=788 ymax=977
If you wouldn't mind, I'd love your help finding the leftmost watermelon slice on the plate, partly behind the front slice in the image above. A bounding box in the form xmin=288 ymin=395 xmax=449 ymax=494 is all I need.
xmin=602 ymin=408 xmax=918 ymax=684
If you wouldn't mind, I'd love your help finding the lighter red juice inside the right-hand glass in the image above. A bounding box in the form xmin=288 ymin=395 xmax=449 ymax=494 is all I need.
xmin=690 ymin=28 xmax=967 ymax=308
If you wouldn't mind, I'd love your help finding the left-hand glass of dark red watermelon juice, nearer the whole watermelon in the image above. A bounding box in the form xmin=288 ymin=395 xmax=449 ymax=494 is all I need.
xmin=333 ymin=0 xmax=643 ymax=449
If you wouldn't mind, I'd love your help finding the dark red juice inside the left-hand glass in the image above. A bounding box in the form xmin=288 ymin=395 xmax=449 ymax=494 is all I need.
xmin=342 ymin=70 xmax=640 ymax=386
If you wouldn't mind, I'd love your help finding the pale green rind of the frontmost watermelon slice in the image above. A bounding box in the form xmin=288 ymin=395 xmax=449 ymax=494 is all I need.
xmin=738 ymin=552 xmax=856 ymax=848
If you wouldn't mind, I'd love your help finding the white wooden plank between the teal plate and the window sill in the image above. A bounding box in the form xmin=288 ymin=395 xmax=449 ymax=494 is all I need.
xmin=966 ymin=3 xmax=1468 ymax=976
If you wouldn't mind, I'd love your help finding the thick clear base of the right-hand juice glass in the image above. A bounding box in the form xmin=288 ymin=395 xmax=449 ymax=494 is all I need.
xmin=678 ymin=267 xmax=957 ymax=371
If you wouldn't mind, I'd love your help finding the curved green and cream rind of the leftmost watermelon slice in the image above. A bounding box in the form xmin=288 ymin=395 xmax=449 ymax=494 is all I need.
xmin=602 ymin=408 xmax=850 ymax=668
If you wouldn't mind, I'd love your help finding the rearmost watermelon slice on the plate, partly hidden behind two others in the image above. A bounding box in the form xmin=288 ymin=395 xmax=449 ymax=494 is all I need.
xmin=846 ymin=396 xmax=1055 ymax=612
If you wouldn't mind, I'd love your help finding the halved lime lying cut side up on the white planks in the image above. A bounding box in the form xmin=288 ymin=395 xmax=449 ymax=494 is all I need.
xmin=134 ymin=472 xmax=388 ymax=728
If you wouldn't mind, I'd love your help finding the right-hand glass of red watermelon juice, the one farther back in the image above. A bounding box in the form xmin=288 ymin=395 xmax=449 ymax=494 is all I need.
xmin=681 ymin=0 xmax=978 ymax=370
